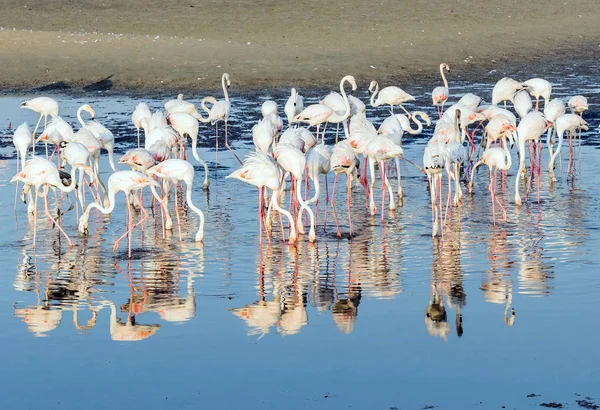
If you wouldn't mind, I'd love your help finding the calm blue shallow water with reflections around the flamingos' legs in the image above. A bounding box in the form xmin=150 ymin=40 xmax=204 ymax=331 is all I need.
xmin=0 ymin=72 xmax=600 ymax=409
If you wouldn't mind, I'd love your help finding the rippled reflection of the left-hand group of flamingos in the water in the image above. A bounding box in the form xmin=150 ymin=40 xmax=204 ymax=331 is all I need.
xmin=14 ymin=240 xmax=203 ymax=341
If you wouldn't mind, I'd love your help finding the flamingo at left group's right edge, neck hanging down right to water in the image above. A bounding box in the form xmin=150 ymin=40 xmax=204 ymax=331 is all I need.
xmin=146 ymin=158 xmax=204 ymax=242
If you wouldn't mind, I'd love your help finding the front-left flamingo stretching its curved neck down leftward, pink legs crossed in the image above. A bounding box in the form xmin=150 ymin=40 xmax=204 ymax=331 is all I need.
xmin=79 ymin=171 xmax=162 ymax=258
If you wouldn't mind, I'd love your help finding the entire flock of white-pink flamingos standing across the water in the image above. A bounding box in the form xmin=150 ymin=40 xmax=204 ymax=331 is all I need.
xmin=11 ymin=64 xmax=588 ymax=257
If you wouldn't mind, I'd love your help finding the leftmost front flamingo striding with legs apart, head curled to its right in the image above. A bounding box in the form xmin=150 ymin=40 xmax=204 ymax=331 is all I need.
xmin=10 ymin=156 xmax=75 ymax=248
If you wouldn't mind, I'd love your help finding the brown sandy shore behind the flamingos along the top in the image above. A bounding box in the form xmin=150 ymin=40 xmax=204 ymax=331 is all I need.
xmin=0 ymin=0 xmax=600 ymax=92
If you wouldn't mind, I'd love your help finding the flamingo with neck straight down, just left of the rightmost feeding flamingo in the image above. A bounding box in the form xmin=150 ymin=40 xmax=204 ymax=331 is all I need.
xmin=515 ymin=111 xmax=552 ymax=205
